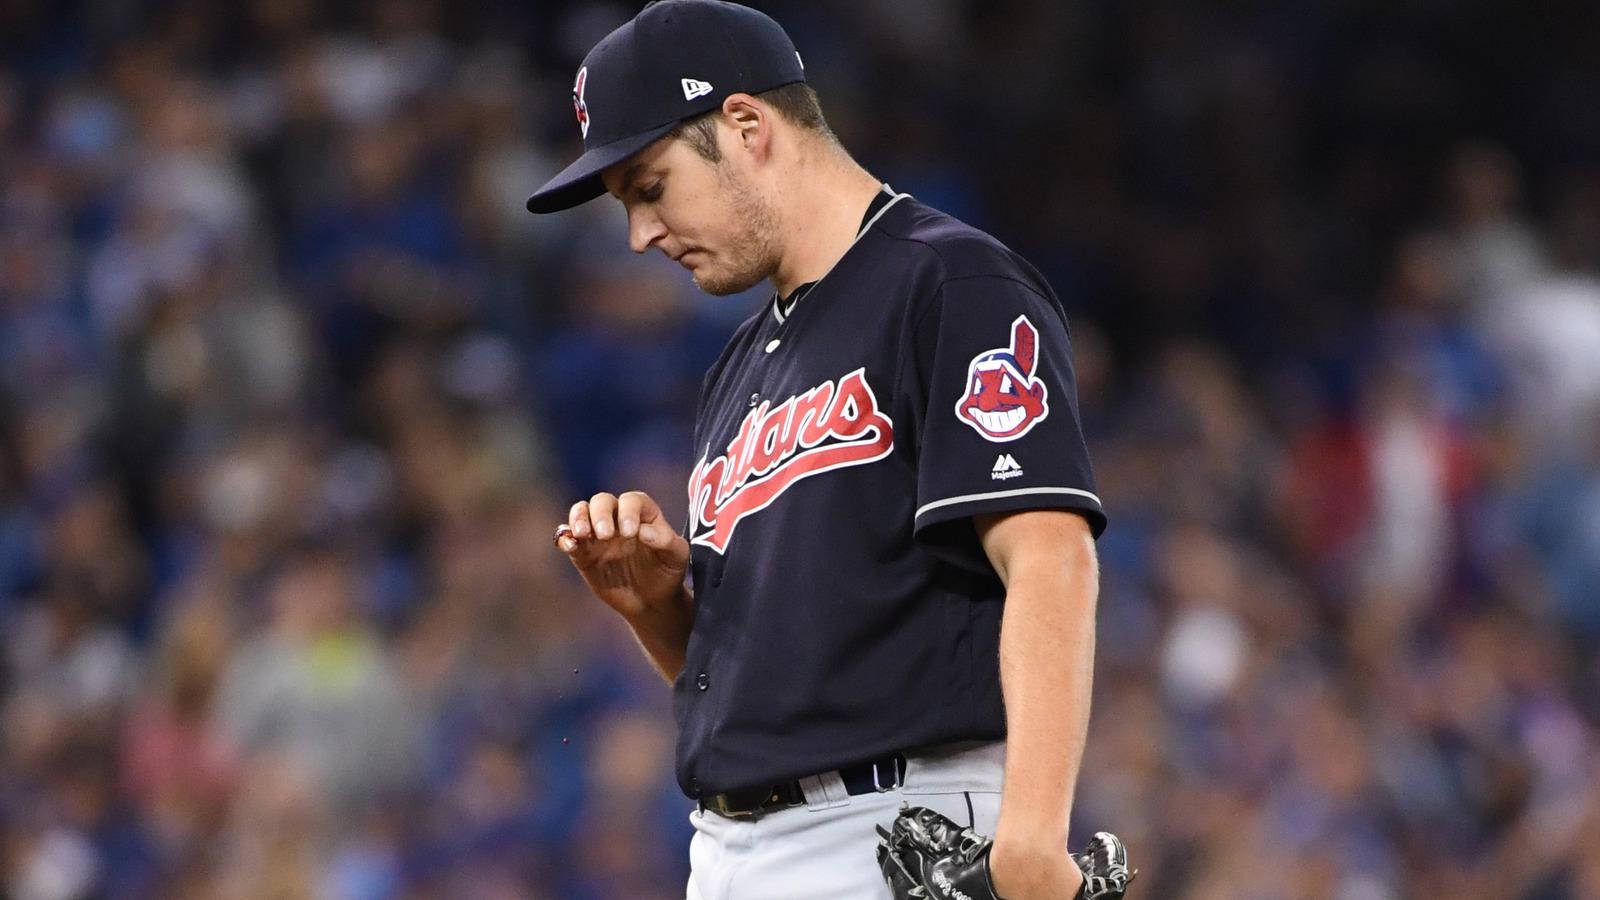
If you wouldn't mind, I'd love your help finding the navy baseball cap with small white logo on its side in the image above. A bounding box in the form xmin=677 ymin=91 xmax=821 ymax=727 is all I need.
xmin=528 ymin=0 xmax=805 ymax=213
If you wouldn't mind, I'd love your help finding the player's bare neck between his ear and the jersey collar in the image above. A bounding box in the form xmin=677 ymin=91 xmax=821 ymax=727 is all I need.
xmin=773 ymin=159 xmax=883 ymax=296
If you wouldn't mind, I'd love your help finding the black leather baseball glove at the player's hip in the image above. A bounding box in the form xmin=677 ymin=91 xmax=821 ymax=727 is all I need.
xmin=878 ymin=806 xmax=1138 ymax=900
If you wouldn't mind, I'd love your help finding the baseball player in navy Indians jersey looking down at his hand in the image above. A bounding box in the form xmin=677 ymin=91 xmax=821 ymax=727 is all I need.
xmin=528 ymin=0 xmax=1128 ymax=900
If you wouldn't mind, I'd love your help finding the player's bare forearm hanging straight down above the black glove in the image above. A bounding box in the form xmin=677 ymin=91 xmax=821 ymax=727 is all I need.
xmin=995 ymin=551 xmax=1099 ymax=850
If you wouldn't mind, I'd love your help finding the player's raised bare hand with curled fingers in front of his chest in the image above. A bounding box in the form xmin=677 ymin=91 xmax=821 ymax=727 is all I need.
xmin=555 ymin=490 xmax=690 ymax=618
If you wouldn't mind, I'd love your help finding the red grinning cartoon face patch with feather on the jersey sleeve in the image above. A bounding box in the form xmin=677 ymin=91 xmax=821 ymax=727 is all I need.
xmin=955 ymin=315 xmax=1050 ymax=442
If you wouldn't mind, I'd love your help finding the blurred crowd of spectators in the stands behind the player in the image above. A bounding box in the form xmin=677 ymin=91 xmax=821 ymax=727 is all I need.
xmin=0 ymin=0 xmax=1600 ymax=900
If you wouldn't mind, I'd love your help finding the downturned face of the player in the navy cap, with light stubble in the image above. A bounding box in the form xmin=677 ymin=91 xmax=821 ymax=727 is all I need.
xmin=602 ymin=129 xmax=778 ymax=296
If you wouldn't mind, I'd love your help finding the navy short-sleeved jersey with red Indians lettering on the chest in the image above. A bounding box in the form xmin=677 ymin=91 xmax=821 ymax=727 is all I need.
xmin=674 ymin=187 xmax=1106 ymax=796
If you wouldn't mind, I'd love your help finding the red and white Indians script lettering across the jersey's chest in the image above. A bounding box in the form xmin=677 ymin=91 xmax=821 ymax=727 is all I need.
xmin=690 ymin=368 xmax=894 ymax=552
